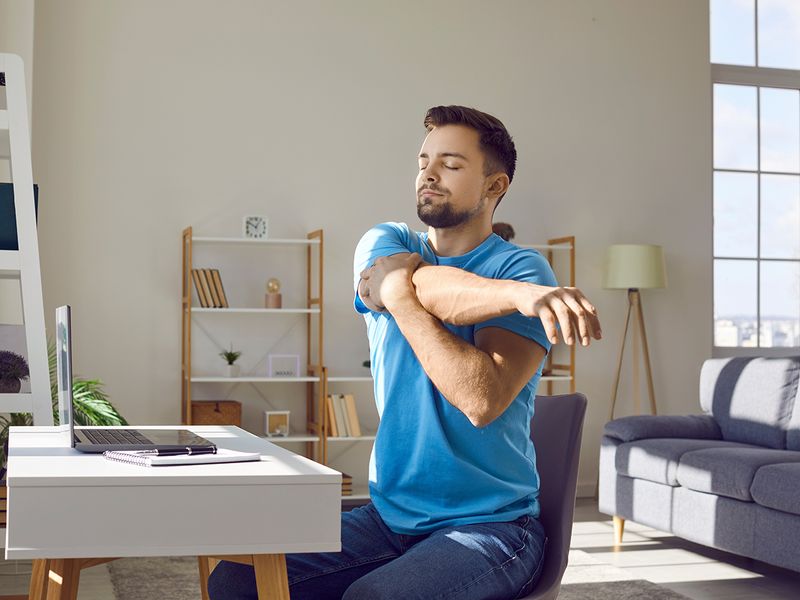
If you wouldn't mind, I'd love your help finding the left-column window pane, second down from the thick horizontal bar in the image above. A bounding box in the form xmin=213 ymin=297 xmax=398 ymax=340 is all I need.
xmin=714 ymin=172 xmax=758 ymax=258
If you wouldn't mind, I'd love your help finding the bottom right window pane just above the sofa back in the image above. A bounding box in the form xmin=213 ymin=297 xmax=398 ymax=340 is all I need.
xmin=760 ymin=260 xmax=800 ymax=348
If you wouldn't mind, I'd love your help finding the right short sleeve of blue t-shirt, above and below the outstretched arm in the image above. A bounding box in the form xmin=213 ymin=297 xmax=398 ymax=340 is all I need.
xmin=475 ymin=249 xmax=558 ymax=352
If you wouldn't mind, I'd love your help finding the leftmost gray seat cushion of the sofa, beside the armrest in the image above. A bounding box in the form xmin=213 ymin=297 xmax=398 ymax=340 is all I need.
xmin=614 ymin=438 xmax=750 ymax=486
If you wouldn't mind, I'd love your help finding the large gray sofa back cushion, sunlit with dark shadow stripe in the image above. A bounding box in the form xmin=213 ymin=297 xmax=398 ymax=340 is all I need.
xmin=700 ymin=356 xmax=800 ymax=448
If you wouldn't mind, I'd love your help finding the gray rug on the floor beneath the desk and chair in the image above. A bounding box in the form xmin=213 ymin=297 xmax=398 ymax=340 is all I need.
xmin=108 ymin=550 xmax=687 ymax=600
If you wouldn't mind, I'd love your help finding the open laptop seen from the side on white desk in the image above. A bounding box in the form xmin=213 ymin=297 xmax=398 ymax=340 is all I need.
xmin=56 ymin=306 xmax=216 ymax=454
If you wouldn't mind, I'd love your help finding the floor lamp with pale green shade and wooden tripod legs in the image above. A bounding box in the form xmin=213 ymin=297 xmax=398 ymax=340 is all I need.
xmin=603 ymin=244 xmax=667 ymax=421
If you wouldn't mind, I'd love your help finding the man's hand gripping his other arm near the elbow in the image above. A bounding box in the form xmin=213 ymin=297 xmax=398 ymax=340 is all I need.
xmin=358 ymin=253 xmax=422 ymax=312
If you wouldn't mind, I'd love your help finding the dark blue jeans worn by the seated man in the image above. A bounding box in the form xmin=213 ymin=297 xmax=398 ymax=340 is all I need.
xmin=208 ymin=504 xmax=545 ymax=600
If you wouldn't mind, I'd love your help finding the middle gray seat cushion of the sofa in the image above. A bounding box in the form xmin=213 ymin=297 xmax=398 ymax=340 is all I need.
xmin=677 ymin=447 xmax=800 ymax=502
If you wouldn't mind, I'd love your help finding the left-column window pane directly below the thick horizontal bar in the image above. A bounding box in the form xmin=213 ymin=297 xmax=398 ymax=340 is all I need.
xmin=714 ymin=83 xmax=758 ymax=171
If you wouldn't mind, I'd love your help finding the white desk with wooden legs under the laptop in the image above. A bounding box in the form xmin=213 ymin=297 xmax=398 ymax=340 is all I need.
xmin=6 ymin=426 xmax=341 ymax=599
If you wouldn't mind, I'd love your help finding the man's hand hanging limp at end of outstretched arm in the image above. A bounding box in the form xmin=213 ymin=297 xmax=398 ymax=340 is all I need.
xmin=516 ymin=283 xmax=603 ymax=346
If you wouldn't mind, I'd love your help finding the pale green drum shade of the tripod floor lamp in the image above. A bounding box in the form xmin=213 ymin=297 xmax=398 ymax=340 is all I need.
xmin=603 ymin=244 xmax=667 ymax=289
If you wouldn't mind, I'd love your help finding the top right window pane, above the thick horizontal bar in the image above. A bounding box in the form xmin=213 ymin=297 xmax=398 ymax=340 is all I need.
xmin=758 ymin=0 xmax=800 ymax=69
